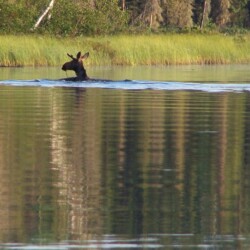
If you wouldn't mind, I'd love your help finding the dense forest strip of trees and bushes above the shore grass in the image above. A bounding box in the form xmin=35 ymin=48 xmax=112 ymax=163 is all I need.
xmin=0 ymin=0 xmax=250 ymax=36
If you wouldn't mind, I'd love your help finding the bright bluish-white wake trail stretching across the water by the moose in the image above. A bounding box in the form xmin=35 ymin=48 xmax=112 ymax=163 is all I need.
xmin=0 ymin=79 xmax=250 ymax=92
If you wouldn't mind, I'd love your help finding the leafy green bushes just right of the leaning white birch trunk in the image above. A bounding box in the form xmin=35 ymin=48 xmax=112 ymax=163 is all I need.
xmin=38 ymin=0 xmax=127 ymax=36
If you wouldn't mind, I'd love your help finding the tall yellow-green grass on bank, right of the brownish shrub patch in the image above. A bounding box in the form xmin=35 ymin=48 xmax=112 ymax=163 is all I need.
xmin=108 ymin=34 xmax=250 ymax=65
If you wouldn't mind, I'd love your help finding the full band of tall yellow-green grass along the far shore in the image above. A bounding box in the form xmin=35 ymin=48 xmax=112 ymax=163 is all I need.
xmin=0 ymin=34 xmax=250 ymax=66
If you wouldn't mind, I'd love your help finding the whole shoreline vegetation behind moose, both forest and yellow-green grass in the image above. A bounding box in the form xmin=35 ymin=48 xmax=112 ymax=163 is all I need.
xmin=0 ymin=0 xmax=250 ymax=66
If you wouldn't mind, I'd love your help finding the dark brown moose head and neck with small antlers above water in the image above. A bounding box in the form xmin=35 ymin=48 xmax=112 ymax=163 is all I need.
xmin=62 ymin=52 xmax=89 ymax=81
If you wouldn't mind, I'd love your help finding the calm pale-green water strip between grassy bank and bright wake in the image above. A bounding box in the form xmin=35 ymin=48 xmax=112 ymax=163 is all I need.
xmin=0 ymin=64 xmax=250 ymax=83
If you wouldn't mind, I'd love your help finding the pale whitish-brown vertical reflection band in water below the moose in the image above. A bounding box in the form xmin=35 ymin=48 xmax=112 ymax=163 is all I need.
xmin=51 ymin=90 xmax=102 ymax=240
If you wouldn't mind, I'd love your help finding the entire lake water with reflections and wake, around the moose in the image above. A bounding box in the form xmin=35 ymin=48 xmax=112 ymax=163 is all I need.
xmin=0 ymin=65 xmax=250 ymax=250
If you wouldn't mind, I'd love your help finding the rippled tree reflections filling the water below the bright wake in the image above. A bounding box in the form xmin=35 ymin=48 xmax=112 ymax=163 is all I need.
xmin=0 ymin=89 xmax=250 ymax=243
